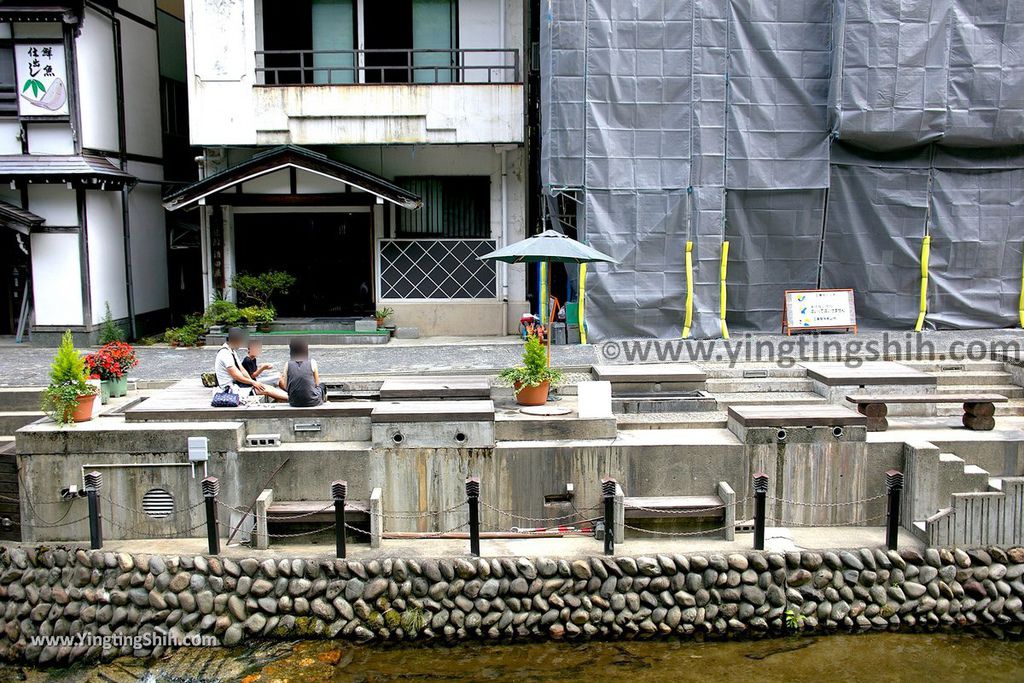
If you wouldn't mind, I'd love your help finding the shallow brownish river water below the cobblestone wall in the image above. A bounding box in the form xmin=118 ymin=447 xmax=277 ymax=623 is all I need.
xmin=8 ymin=633 xmax=1024 ymax=683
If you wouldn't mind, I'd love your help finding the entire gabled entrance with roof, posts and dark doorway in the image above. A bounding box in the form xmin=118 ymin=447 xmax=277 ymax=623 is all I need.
xmin=164 ymin=145 xmax=421 ymax=317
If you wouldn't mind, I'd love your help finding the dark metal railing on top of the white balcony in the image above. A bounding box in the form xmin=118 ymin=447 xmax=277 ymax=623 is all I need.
xmin=248 ymin=48 xmax=520 ymax=85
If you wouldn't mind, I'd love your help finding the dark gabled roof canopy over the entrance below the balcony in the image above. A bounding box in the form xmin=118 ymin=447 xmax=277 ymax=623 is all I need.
xmin=164 ymin=144 xmax=422 ymax=211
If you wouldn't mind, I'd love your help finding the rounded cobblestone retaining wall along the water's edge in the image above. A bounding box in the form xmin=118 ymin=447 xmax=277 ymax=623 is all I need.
xmin=0 ymin=547 xmax=1024 ymax=664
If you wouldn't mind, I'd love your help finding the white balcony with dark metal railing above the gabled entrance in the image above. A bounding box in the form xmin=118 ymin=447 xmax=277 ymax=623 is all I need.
xmin=241 ymin=48 xmax=524 ymax=145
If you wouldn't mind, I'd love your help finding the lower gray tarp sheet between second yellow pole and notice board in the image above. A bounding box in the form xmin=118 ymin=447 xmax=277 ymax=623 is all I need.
xmin=725 ymin=189 xmax=824 ymax=332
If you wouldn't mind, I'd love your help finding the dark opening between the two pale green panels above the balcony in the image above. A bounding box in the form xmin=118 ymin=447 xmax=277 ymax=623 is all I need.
xmin=362 ymin=0 xmax=413 ymax=83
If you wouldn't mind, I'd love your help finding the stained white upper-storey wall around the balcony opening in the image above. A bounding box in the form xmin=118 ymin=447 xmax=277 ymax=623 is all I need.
xmin=185 ymin=0 xmax=524 ymax=145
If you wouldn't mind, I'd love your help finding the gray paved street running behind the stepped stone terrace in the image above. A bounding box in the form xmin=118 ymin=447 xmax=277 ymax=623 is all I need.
xmin=0 ymin=330 xmax=1024 ymax=386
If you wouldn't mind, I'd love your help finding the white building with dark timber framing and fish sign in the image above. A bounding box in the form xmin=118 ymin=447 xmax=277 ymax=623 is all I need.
xmin=0 ymin=0 xmax=173 ymax=341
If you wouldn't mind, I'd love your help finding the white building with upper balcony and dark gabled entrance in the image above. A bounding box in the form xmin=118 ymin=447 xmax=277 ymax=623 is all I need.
xmin=172 ymin=0 xmax=527 ymax=335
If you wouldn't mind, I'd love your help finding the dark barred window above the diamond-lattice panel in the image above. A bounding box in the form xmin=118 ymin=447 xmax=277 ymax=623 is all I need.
xmin=396 ymin=175 xmax=490 ymax=239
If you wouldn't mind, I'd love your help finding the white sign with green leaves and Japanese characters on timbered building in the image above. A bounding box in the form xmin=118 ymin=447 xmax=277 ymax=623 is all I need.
xmin=14 ymin=43 xmax=69 ymax=117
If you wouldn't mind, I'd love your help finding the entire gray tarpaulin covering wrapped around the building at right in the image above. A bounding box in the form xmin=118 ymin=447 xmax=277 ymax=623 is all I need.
xmin=541 ymin=0 xmax=1024 ymax=339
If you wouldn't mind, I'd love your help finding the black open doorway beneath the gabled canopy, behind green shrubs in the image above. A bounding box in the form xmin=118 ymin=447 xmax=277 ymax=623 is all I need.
xmin=234 ymin=213 xmax=374 ymax=317
